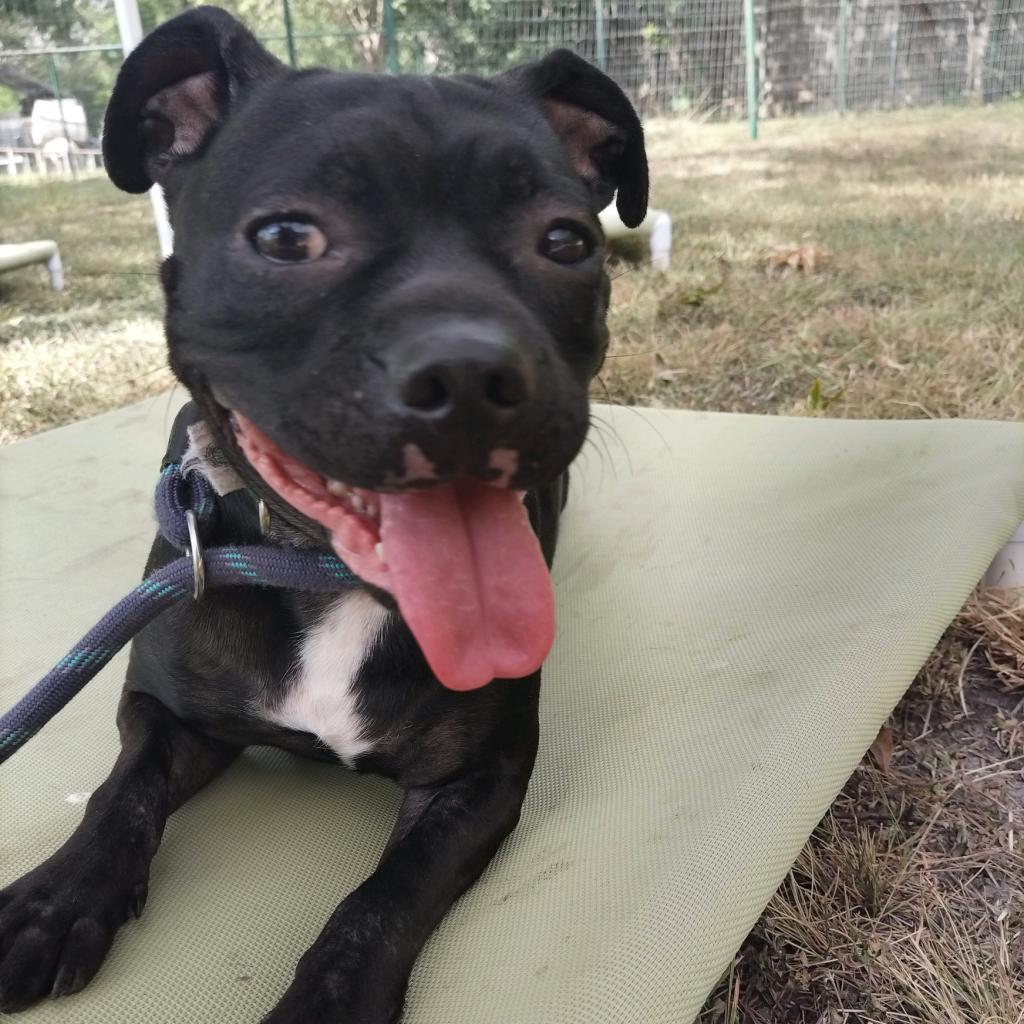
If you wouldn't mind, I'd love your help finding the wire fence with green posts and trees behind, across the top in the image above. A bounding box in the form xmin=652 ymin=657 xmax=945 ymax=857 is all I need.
xmin=0 ymin=0 xmax=1024 ymax=161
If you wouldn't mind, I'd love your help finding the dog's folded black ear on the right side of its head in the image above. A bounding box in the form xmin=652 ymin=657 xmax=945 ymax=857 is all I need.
xmin=498 ymin=50 xmax=647 ymax=227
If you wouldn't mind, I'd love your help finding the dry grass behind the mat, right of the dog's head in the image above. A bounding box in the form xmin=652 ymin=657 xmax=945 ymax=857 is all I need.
xmin=599 ymin=105 xmax=1024 ymax=418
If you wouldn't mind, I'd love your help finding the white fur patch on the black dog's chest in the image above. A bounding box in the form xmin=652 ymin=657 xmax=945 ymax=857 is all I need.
xmin=267 ymin=590 xmax=388 ymax=765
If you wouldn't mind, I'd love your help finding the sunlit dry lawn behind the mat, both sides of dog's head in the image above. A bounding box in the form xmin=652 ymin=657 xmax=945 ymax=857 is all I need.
xmin=6 ymin=104 xmax=1024 ymax=442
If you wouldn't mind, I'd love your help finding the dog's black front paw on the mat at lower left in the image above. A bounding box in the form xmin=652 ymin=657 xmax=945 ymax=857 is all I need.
xmin=0 ymin=851 xmax=146 ymax=1014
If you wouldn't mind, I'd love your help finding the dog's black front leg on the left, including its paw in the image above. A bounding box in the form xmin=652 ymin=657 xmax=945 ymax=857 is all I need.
xmin=0 ymin=690 xmax=238 ymax=1012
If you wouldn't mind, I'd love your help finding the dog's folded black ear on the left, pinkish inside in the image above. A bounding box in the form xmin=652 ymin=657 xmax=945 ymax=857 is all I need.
xmin=103 ymin=7 xmax=287 ymax=193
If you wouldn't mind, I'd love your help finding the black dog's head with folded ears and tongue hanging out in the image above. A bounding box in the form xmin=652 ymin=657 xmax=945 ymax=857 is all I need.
xmin=103 ymin=7 xmax=647 ymax=686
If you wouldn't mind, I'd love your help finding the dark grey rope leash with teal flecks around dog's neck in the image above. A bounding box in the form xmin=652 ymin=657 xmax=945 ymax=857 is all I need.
xmin=0 ymin=463 xmax=358 ymax=764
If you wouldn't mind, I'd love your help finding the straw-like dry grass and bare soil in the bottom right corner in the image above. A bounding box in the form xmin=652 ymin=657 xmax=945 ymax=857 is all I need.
xmin=700 ymin=595 xmax=1024 ymax=1024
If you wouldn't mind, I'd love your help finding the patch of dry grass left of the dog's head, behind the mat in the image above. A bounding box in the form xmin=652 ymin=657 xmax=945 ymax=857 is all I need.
xmin=0 ymin=178 xmax=171 ymax=443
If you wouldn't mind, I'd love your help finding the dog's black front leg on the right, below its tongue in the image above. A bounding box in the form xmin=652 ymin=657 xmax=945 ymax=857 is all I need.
xmin=263 ymin=704 xmax=537 ymax=1024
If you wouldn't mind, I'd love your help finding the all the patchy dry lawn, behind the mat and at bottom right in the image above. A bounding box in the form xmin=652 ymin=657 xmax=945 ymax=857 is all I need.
xmin=0 ymin=104 xmax=1024 ymax=1024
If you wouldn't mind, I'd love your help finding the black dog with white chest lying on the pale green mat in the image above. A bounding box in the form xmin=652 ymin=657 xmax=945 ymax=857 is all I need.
xmin=0 ymin=7 xmax=647 ymax=1024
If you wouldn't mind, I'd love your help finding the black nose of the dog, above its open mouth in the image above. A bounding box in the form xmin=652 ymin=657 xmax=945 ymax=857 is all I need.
xmin=388 ymin=318 xmax=536 ymax=423
